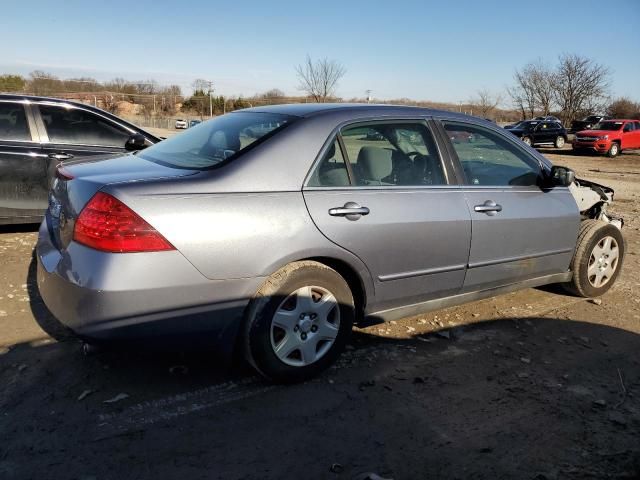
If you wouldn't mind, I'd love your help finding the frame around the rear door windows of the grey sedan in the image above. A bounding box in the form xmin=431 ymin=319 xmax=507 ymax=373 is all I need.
xmin=302 ymin=116 xmax=458 ymax=191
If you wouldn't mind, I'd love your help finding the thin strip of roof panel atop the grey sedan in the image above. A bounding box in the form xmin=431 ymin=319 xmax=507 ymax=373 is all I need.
xmin=237 ymin=103 xmax=472 ymax=119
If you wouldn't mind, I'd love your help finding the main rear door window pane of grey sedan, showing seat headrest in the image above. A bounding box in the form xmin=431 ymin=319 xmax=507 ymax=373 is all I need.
xmin=341 ymin=123 xmax=447 ymax=186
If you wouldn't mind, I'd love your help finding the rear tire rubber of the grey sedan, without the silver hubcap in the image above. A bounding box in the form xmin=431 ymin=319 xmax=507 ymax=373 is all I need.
xmin=244 ymin=261 xmax=355 ymax=383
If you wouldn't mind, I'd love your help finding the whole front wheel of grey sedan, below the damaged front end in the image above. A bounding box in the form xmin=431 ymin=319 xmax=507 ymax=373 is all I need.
xmin=565 ymin=220 xmax=625 ymax=297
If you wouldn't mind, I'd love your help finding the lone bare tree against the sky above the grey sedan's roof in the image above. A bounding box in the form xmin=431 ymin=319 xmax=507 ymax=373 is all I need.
xmin=296 ymin=55 xmax=347 ymax=103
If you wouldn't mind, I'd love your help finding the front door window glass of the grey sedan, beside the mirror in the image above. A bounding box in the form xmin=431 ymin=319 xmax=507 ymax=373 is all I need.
xmin=444 ymin=122 xmax=541 ymax=186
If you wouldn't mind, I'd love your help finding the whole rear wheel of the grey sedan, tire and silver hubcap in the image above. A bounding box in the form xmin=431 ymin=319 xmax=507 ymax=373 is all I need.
xmin=244 ymin=261 xmax=354 ymax=382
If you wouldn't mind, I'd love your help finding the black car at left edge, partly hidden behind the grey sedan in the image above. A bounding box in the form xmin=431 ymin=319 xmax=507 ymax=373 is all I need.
xmin=0 ymin=95 xmax=160 ymax=224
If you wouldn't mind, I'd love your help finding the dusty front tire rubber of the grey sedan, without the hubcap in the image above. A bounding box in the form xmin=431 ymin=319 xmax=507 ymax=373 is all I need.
xmin=564 ymin=220 xmax=625 ymax=298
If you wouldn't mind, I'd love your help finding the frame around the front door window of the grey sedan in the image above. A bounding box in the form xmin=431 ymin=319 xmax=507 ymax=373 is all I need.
xmin=436 ymin=117 xmax=550 ymax=191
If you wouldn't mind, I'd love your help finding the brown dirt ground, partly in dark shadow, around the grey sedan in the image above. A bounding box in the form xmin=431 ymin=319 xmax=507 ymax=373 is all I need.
xmin=0 ymin=149 xmax=640 ymax=480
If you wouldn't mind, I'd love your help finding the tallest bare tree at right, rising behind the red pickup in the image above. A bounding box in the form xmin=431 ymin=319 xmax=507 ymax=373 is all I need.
xmin=553 ymin=54 xmax=610 ymax=123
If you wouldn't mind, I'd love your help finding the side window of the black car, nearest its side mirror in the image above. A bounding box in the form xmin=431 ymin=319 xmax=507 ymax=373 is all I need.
xmin=39 ymin=105 xmax=131 ymax=148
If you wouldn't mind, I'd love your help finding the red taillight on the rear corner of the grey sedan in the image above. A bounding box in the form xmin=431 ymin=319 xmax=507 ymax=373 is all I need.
xmin=73 ymin=192 xmax=175 ymax=253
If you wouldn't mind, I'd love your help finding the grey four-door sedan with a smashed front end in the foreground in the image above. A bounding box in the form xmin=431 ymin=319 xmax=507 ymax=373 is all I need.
xmin=36 ymin=104 xmax=625 ymax=382
